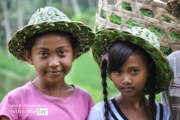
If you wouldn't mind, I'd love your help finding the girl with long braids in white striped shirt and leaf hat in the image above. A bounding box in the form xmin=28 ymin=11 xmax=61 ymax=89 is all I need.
xmin=88 ymin=28 xmax=172 ymax=120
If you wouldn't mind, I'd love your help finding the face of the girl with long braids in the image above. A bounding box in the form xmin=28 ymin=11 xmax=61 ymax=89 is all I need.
xmin=111 ymin=54 xmax=149 ymax=96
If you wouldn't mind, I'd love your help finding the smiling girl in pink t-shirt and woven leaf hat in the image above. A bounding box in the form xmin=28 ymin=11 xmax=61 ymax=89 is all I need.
xmin=0 ymin=7 xmax=95 ymax=120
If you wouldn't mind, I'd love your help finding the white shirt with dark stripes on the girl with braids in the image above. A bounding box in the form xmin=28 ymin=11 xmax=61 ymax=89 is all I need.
xmin=87 ymin=99 xmax=171 ymax=120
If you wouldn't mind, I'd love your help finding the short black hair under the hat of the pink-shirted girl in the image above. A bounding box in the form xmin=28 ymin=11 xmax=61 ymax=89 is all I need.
xmin=24 ymin=31 xmax=78 ymax=54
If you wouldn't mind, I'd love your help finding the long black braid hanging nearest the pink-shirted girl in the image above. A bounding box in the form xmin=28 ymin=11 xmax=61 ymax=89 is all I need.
xmin=101 ymin=60 xmax=110 ymax=120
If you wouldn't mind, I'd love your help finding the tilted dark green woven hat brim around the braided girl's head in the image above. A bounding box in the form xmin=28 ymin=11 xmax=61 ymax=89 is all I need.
xmin=92 ymin=28 xmax=172 ymax=94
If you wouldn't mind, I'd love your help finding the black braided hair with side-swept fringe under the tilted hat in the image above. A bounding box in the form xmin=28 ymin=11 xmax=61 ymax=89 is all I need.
xmin=101 ymin=41 xmax=156 ymax=120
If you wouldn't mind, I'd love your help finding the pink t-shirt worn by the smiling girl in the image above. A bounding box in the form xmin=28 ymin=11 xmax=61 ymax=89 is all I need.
xmin=0 ymin=82 xmax=94 ymax=120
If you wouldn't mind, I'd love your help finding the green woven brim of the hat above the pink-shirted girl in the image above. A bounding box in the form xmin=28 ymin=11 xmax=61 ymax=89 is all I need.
xmin=8 ymin=21 xmax=95 ymax=61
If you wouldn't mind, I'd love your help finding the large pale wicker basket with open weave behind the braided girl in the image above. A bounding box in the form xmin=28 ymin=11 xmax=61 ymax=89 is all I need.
xmin=95 ymin=0 xmax=180 ymax=55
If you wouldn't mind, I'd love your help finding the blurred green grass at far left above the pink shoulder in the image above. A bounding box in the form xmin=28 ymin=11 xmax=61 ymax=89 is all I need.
xmin=0 ymin=52 xmax=35 ymax=101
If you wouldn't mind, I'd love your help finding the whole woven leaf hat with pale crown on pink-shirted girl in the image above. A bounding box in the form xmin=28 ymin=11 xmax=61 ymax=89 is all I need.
xmin=8 ymin=7 xmax=95 ymax=61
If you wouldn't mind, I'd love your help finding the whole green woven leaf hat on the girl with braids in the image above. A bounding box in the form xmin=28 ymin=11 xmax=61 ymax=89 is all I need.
xmin=92 ymin=28 xmax=172 ymax=94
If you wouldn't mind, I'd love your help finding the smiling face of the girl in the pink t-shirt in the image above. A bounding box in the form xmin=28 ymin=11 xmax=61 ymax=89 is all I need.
xmin=25 ymin=33 xmax=78 ymax=82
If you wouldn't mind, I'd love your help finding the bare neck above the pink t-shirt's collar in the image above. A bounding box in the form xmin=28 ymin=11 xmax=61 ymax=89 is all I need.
xmin=32 ymin=76 xmax=74 ymax=97
